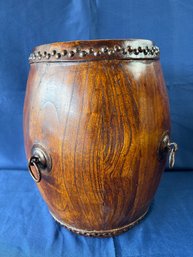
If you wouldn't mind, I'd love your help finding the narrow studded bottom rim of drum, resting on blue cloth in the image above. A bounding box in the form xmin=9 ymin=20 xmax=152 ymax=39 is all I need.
xmin=50 ymin=207 xmax=149 ymax=237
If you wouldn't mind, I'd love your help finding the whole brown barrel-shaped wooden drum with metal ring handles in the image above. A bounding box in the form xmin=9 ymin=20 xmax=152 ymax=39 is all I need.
xmin=24 ymin=40 xmax=177 ymax=237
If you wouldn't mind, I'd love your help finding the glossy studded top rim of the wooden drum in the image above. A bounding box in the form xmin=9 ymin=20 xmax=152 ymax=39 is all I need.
xmin=29 ymin=40 xmax=160 ymax=63
